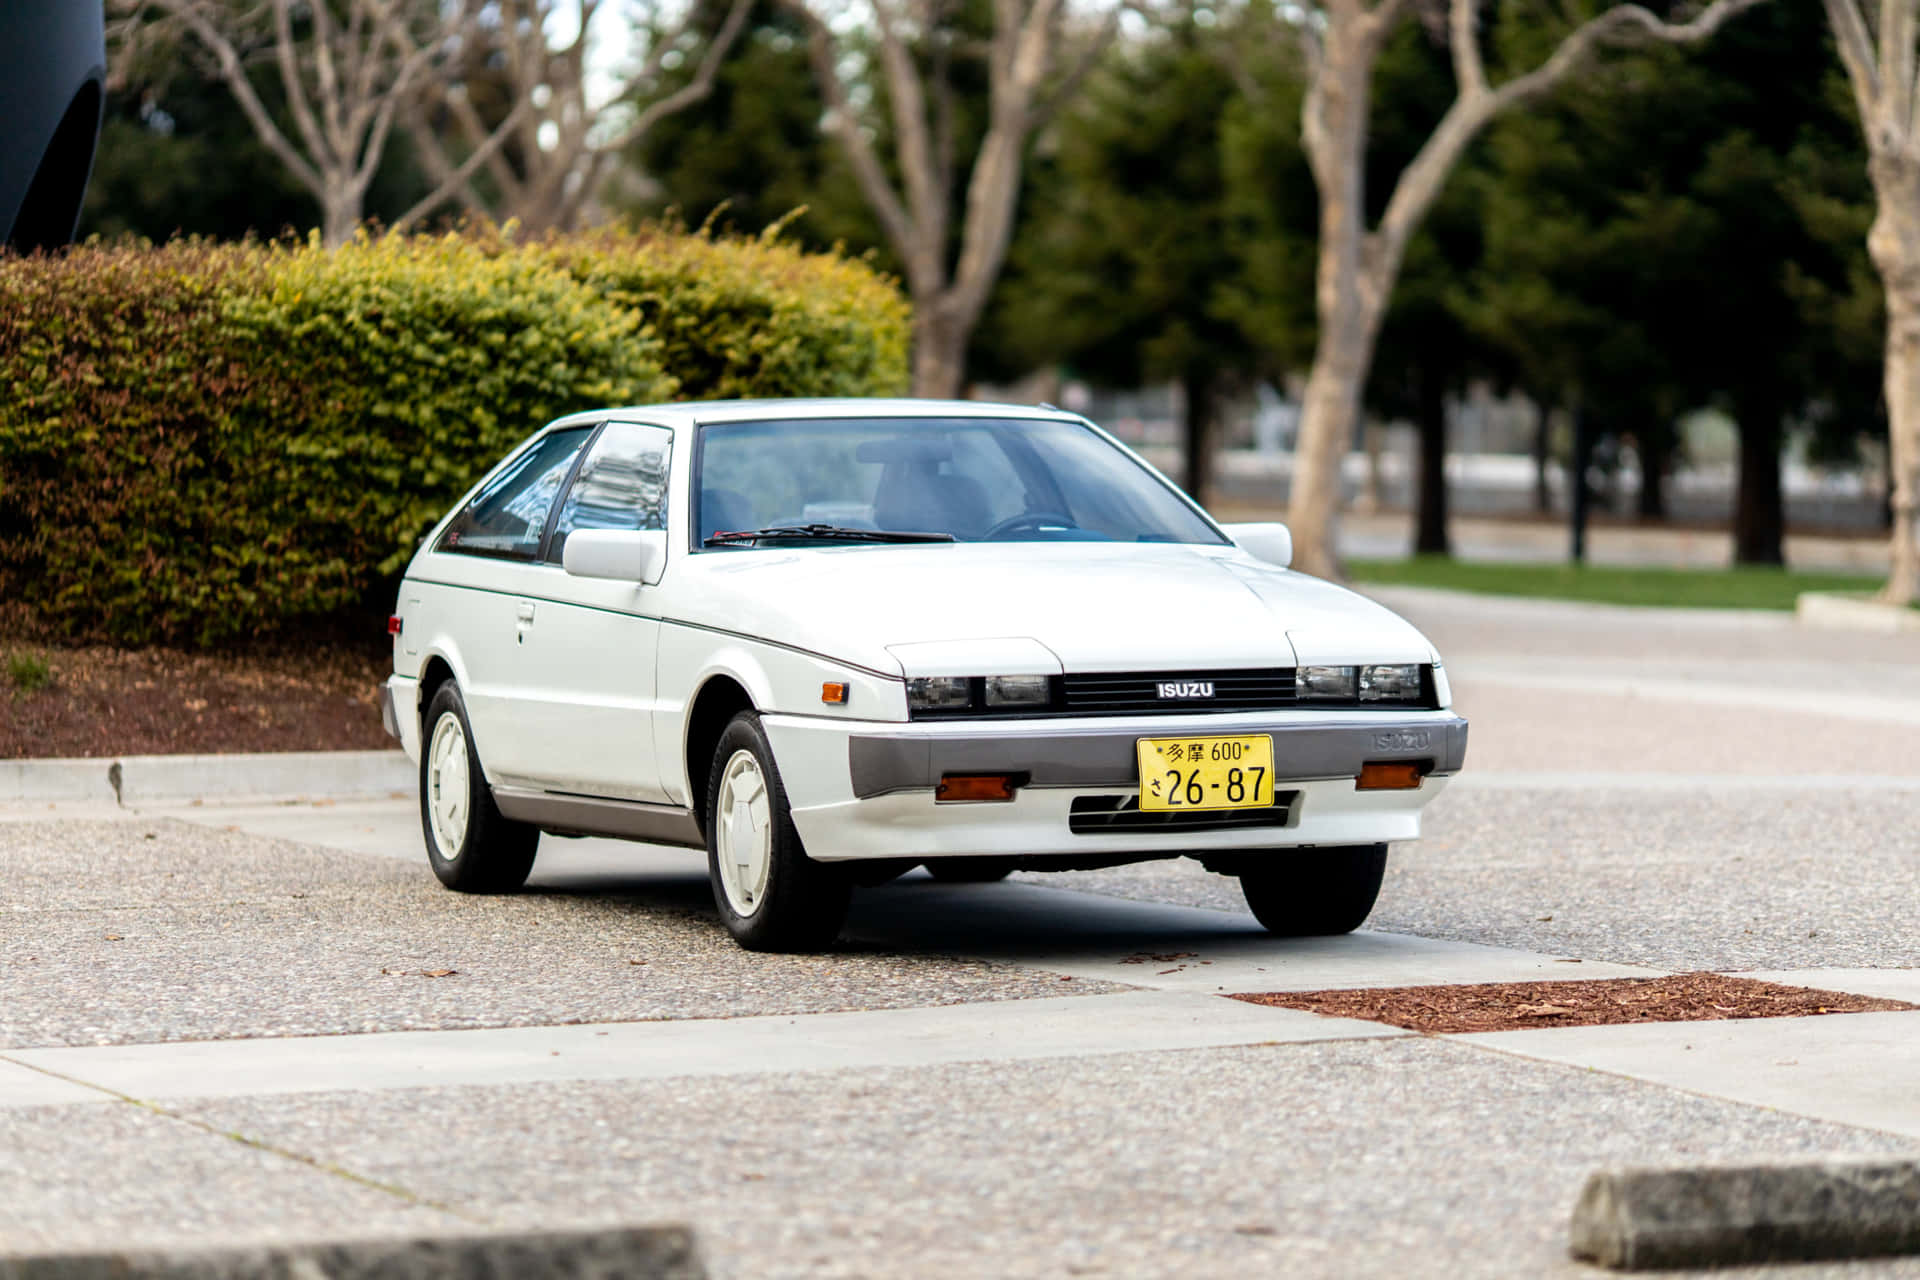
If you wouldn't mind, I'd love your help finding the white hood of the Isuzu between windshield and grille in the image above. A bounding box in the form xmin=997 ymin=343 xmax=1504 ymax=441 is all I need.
xmin=687 ymin=543 xmax=1432 ymax=676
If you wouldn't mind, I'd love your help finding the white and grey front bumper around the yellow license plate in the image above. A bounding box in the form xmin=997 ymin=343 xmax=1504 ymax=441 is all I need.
xmin=762 ymin=712 xmax=1467 ymax=862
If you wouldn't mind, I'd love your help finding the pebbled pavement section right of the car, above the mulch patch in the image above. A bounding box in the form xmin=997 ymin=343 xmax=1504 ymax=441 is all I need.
xmin=1021 ymin=789 xmax=1920 ymax=971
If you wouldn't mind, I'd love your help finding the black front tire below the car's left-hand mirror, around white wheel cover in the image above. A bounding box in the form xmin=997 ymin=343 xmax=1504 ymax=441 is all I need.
xmin=707 ymin=712 xmax=852 ymax=952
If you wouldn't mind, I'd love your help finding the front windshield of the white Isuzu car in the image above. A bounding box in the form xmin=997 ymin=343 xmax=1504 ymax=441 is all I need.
xmin=695 ymin=418 xmax=1225 ymax=547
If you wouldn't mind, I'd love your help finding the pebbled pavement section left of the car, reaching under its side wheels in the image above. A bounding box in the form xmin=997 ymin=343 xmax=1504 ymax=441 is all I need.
xmin=0 ymin=821 xmax=1123 ymax=1048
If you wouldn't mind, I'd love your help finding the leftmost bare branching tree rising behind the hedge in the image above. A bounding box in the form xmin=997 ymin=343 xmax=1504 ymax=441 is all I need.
xmin=109 ymin=0 xmax=522 ymax=246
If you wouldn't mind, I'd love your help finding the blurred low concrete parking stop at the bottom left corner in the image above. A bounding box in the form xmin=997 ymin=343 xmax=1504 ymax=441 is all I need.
xmin=0 ymin=1226 xmax=707 ymax=1280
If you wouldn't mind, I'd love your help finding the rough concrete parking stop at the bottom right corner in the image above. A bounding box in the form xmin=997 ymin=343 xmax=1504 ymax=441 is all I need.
xmin=1569 ymin=1161 xmax=1920 ymax=1270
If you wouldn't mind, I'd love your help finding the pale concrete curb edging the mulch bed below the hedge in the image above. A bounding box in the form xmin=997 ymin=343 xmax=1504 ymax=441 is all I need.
xmin=0 ymin=750 xmax=417 ymax=808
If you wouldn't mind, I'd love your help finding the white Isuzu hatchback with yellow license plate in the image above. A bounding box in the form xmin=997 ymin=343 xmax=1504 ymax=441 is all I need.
xmin=384 ymin=399 xmax=1467 ymax=950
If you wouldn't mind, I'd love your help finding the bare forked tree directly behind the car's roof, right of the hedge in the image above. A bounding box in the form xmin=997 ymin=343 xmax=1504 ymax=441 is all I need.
xmin=785 ymin=0 xmax=1121 ymax=397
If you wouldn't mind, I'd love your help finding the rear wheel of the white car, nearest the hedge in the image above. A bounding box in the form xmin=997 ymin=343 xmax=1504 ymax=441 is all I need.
xmin=420 ymin=679 xmax=540 ymax=894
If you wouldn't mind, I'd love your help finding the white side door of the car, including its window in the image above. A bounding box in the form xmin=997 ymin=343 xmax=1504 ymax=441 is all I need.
xmin=518 ymin=422 xmax=674 ymax=802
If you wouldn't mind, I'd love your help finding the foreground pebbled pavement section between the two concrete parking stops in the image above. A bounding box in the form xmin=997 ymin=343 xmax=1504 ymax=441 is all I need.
xmin=131 ymin=1038 xmax=1920 ymax=1280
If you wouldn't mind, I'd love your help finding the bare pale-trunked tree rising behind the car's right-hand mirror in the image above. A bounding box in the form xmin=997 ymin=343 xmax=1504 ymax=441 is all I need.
xmin=1281 ymin=0 xmax=1766 ymax=576
